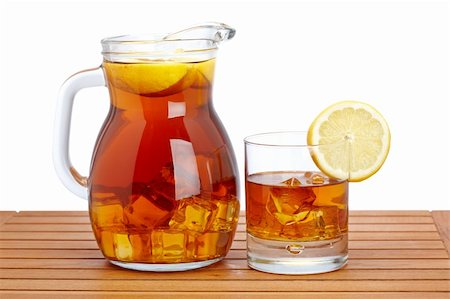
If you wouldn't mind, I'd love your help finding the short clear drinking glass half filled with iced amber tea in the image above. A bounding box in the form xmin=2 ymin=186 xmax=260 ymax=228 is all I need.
xmin=245 ymin=132 xmax=348 ymax=274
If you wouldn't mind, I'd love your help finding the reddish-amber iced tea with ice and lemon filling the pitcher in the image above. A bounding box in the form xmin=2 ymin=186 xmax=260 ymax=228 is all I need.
xmin=89 ymin=60 xmax=239 ymax=263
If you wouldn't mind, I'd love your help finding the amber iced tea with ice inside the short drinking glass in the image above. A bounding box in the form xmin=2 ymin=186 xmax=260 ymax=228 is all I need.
xmin=246 ymin=172 xmax=348 ymax=242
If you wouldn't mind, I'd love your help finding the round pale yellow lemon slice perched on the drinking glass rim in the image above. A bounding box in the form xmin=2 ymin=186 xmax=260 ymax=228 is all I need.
xmin=308 ymin=101 xmax=391 ymax=182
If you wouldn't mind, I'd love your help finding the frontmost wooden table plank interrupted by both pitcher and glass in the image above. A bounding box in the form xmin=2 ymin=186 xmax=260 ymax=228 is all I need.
xmin=0 ymin=249 xmax=448 ymax=259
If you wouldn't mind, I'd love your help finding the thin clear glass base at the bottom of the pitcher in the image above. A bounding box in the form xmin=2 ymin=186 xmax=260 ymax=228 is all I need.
xmin=109 ymin=257 xmax=223 ymax=272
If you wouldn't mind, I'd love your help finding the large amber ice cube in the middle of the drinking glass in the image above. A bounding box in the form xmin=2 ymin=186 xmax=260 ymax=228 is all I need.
xmin=266 ymin=187 xmax=315 ymax=225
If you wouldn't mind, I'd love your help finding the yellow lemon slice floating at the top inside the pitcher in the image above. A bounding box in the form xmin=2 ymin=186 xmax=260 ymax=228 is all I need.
xmin=104 ymin=62 xmax=195 ymax=95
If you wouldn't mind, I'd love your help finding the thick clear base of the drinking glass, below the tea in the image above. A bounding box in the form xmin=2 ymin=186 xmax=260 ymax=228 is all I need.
xmin=247 ymin=234 xmax=348 ymax=274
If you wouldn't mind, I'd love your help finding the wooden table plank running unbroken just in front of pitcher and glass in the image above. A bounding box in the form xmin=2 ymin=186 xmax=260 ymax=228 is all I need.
xmin=0 ymin=268 xmax=450 ymax=281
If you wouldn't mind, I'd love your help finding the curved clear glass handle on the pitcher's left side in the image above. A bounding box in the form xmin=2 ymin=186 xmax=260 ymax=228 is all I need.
xmin=53 ymin=67 xmax=106 ymax=199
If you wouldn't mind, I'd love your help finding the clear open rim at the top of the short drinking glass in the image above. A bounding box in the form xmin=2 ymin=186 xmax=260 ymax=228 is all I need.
xmin=244 ymin=131 xmax=338 ymax=148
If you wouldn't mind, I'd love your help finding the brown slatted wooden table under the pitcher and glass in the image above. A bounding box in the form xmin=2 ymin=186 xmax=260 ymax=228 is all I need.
xmin=0 ymin=211 xmax=450 ymax=299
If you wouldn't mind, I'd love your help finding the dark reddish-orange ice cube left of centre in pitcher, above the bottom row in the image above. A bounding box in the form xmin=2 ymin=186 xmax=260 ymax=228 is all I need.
xmin=124 ymin=184 xmax=177 ymax=229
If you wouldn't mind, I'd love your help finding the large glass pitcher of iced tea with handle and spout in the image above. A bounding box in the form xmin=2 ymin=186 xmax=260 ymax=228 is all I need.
xmin=54 ymin=23 xmax=239 ymax=271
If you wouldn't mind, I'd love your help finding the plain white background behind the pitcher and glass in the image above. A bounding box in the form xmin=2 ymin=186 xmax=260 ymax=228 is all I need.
xmin=0 ymin=0 xmax=450 ymax=210
